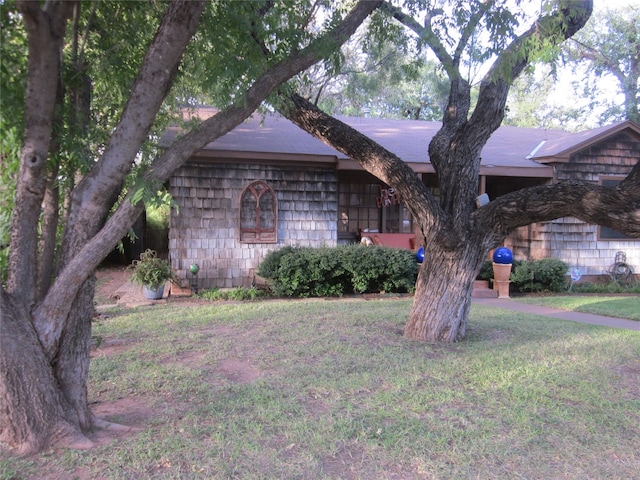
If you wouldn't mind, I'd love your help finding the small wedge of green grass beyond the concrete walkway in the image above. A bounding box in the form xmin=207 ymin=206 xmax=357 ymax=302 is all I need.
xmin=513 ymin=295 xmax=640 ymax=320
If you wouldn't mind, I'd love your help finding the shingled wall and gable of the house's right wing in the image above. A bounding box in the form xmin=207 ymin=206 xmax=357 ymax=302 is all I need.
xmin=505 ymin=133 xmax=640 ymax=275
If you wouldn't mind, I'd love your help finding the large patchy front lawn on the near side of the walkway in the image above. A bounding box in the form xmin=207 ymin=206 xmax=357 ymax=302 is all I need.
xmin=0 ymin=298 xmax=640 ymax=480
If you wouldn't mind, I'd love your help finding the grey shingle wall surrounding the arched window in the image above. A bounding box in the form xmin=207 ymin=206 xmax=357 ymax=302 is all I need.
xmin=169 ymin=163 xmax=338 ymax=289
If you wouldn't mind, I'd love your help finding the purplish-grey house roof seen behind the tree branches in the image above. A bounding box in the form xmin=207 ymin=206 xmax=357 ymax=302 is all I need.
xmin=163 ymin=108 xmax=640 ymax=177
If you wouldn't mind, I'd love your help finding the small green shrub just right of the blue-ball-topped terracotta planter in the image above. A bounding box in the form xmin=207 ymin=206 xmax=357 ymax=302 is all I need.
xmin=510 ymin=258 xmax=568 ymax=292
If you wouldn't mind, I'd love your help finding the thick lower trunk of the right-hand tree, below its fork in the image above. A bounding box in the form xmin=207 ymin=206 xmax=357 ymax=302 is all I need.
xmin=404 ymin=242 xmax=486 ymax=343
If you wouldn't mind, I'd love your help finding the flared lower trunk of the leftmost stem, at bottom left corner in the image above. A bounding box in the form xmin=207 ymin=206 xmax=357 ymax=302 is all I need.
xmin=0 ymin=290 xmax=91 ymax=454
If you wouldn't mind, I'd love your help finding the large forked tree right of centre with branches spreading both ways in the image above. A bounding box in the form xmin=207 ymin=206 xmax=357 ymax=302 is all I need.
xmin=279 ymin=1 xmax=640 ymax=342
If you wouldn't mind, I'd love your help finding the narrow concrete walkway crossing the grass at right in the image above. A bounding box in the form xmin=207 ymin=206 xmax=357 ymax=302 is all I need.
xmin=472 ymin=298 xmax=640 ymax=331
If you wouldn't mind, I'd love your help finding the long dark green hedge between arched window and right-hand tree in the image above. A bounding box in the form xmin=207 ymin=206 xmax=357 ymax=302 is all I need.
xmin=258 ymin=244 xmax=418 ymax=297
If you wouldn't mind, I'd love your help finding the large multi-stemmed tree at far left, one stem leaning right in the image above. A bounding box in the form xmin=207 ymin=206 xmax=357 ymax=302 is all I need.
xmin=0 ymin=0 xmax=380 ymax=453
